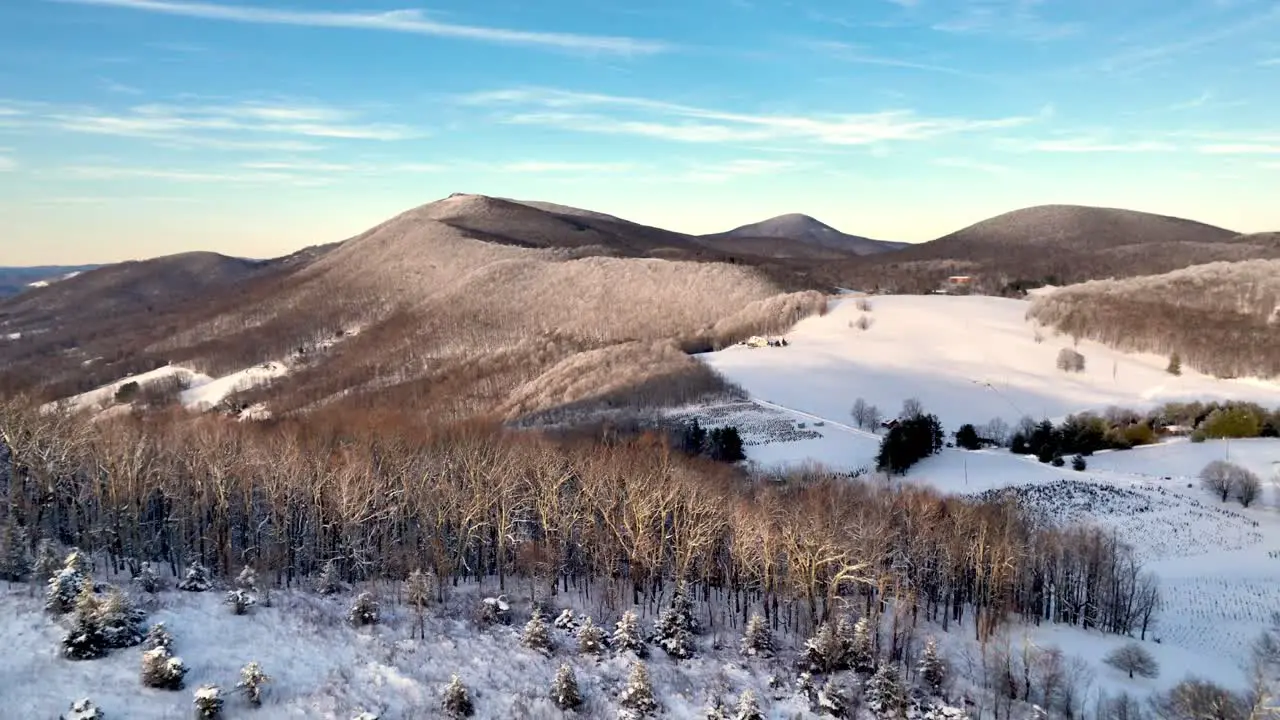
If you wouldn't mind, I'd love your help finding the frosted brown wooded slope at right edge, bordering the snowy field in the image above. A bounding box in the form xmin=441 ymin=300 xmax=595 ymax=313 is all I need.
xmin=1029 ymin=260 xmax=1280 ymax=377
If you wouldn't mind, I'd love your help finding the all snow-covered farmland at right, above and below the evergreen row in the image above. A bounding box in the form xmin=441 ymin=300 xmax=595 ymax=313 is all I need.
xmin=675 ymin=289 xmax=1280 ymax=692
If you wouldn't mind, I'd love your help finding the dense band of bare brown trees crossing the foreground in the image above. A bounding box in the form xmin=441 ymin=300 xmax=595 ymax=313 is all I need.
xmin=0 ymin=400 xmax=1158 ymax=638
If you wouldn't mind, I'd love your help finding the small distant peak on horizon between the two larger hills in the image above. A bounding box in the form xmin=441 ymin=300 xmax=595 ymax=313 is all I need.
xmin=701 ymin=214 xmax=908 ymax=258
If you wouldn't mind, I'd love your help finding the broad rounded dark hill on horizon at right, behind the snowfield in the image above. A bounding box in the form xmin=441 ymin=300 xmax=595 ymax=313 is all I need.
xmin=841 ymin=205 xmax=1280 ymax=293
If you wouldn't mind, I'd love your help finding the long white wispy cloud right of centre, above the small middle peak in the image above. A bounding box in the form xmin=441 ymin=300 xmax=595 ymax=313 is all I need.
xmin=462 ymin=88 xmax=1036 ymax=146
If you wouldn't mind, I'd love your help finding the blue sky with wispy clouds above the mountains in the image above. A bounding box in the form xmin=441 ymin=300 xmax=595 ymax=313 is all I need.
xmin=0 ymin=0 xmax=1280 ymax=265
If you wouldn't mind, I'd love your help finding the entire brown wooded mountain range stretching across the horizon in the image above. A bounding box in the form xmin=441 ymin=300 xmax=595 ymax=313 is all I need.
xmin=0 ymin=193 xmax=1280 ymax=420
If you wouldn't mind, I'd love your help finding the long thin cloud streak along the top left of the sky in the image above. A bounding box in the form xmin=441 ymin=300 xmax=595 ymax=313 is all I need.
xmin=55 ymin=0 xmax=667 ymax=55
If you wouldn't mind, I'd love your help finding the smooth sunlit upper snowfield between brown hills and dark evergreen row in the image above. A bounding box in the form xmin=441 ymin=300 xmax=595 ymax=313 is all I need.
xmin=699 ymin=295 xmax=1280 ymax=430
